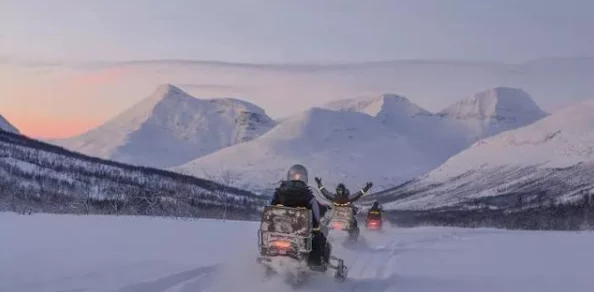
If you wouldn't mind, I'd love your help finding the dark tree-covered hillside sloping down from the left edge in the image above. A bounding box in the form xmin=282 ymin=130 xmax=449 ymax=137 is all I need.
xmin=0 ymin=130 xmax=266 ymax=220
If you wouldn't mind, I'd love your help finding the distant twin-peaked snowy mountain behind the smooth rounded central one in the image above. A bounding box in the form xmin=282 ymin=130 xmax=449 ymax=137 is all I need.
xmin=326 ymin=87 xmax=546 ymax=166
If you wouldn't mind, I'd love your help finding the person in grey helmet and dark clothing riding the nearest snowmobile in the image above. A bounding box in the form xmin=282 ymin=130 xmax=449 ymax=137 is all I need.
xmin=270 ymin=164 xmax=330 ymax=269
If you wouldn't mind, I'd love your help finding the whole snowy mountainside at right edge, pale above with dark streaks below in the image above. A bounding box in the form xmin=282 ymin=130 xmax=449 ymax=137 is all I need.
xmin=375 ymin=100 xmax=594 ymax=209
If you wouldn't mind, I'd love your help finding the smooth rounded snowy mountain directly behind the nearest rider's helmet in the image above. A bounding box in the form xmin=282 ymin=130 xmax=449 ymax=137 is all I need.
xmin=174 ymin=108 xmax=434 ymax=190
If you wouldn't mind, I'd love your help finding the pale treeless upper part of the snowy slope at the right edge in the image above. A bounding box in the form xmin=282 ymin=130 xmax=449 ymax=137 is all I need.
xmin=436 ymin=99 xmax=594 ymax=178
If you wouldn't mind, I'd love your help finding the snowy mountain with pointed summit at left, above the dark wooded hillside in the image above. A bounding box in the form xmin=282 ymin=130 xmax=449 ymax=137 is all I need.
xmin=52 ymin=85 xmax=275 ymax=167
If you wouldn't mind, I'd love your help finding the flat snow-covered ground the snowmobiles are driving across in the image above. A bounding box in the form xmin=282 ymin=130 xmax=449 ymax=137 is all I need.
xmin=0 ymin=213 xmax=594 ymax=292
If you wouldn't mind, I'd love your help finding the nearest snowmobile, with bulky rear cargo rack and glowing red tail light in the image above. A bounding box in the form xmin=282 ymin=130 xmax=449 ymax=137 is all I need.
xmin=257 ymin=206 xmax=348 ymax=286
